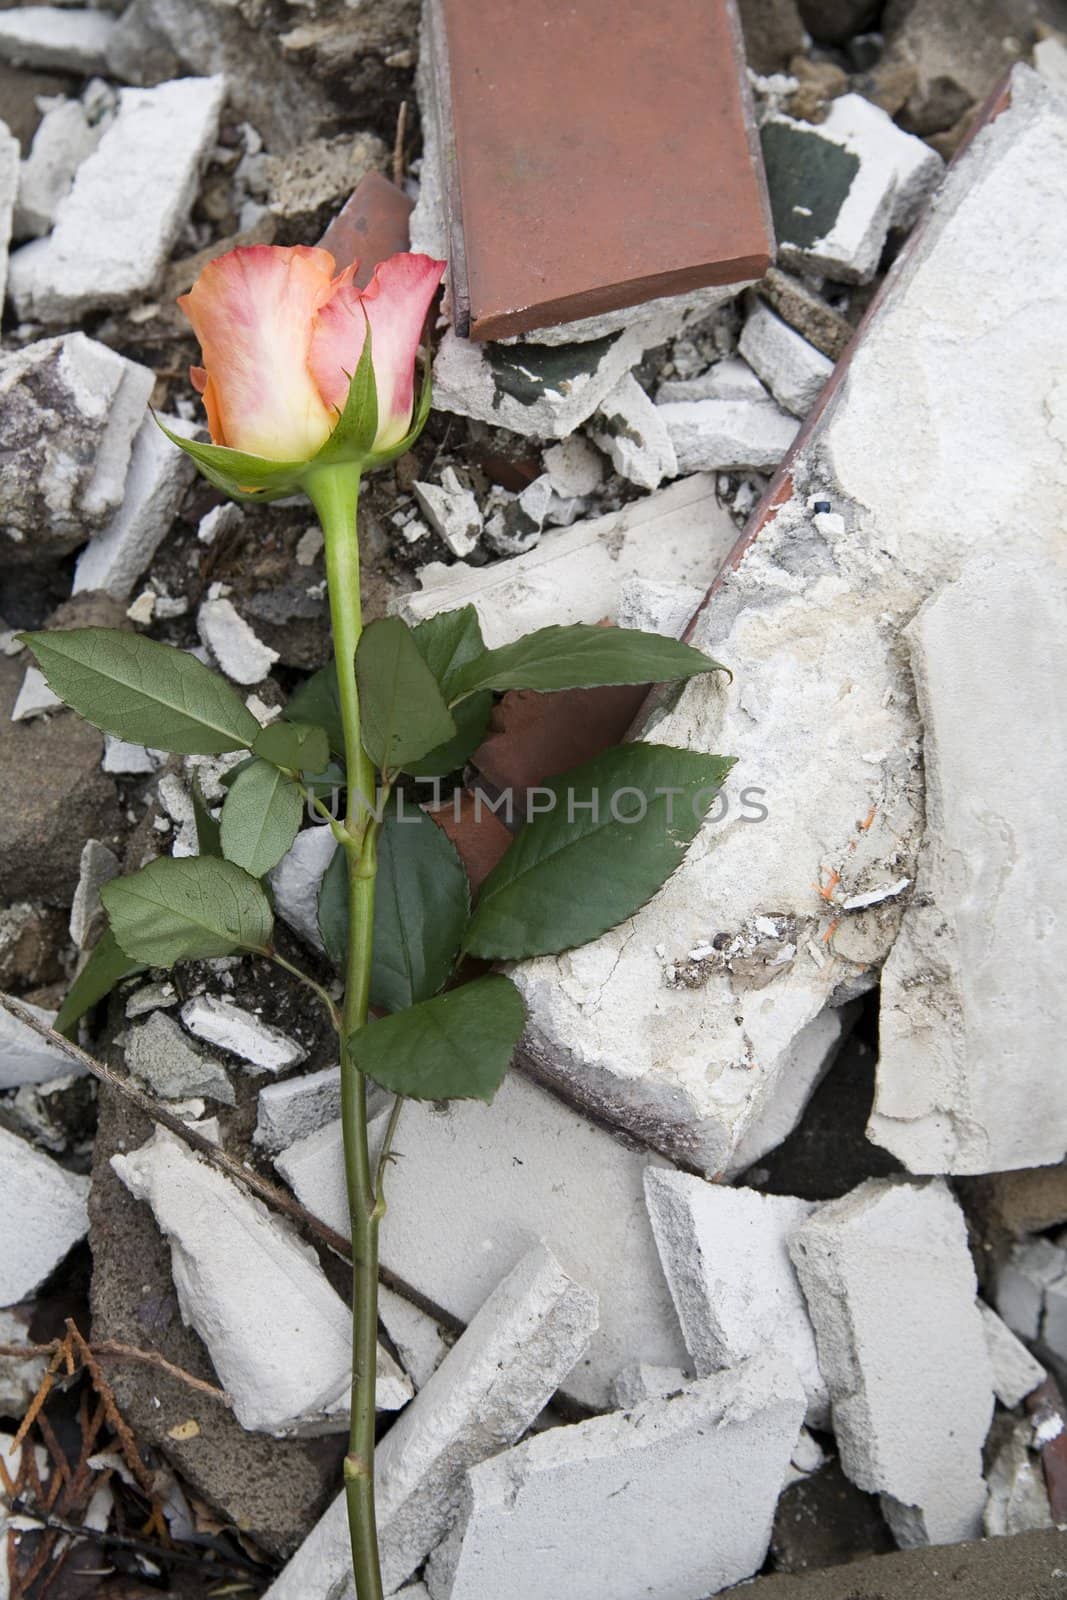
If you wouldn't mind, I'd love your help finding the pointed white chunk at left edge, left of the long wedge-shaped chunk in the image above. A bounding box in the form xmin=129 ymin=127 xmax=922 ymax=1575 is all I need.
xmin=0 ymin=1120 xmax=90 ymax=1306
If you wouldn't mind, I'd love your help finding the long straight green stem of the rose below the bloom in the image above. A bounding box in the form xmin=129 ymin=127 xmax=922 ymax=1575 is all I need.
xmin=304 ymin=464 xmax=384 ymax=1600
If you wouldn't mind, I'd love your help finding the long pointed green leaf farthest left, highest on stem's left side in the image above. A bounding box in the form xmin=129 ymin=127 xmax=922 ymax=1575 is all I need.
xmin=19 ymin=627 xmax=259 ymax=755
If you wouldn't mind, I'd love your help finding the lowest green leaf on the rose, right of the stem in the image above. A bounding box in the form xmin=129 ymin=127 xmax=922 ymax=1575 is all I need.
xmin=349 ymin=973 xmax=526 ymax=1101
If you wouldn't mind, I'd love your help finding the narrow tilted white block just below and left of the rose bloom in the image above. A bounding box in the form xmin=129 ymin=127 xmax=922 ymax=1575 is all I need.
xmin=74 ymin=416 xmax=198 ymax=600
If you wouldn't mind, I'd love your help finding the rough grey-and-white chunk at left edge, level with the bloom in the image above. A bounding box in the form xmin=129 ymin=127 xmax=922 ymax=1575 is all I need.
xmin=0 ymin=333 xmax=158 ymax=563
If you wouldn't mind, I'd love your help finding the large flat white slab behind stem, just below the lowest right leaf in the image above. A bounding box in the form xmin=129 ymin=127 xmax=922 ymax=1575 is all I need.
xmin=275 ymin=1072 xmax=688 ymax=1406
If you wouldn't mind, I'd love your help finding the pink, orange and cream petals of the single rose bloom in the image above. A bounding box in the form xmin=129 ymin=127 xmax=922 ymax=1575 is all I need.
xmin=178 ymin=245 xmax=445 ymax=461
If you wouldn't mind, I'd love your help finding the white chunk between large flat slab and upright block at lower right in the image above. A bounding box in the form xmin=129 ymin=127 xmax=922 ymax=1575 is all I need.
xmin=645 ymin=1168 xmax=830 ymax=1427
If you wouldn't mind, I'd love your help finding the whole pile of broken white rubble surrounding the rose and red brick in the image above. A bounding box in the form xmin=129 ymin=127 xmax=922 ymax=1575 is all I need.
xmin=0 ymin=0 xmax=1067 ymax=1600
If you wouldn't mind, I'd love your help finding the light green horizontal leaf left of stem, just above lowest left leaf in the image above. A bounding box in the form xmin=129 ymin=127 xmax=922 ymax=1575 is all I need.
xmin=101 ymin=856 xmax=274 ymax=966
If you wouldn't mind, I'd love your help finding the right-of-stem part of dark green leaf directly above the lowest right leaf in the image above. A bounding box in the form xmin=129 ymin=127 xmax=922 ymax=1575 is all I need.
xmin=371 ymin=806 xmax=470 ymax=1011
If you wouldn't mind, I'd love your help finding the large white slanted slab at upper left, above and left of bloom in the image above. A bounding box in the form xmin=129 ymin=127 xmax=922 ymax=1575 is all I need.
xmin=8 ymin=74 xmax=226 ymax=323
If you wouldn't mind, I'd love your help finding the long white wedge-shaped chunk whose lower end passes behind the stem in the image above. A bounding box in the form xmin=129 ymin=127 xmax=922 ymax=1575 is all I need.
xmin=112 ymin=1130 xmax=411 ymax=1434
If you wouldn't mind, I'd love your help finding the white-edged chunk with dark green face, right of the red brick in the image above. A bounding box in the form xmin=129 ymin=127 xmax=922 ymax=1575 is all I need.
xmin=760 ymin=114 xmax=896 ymax=283
